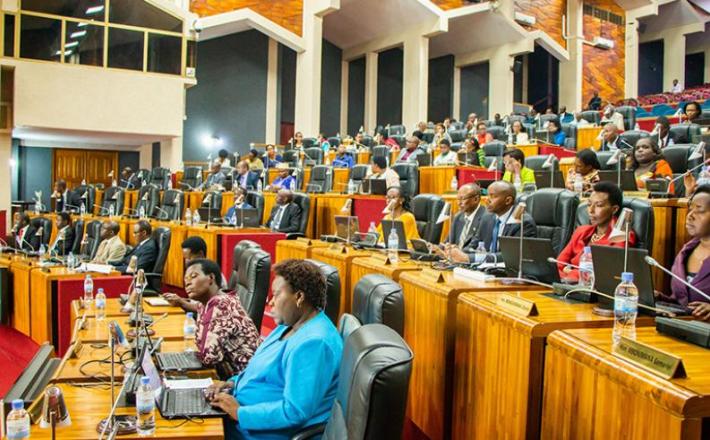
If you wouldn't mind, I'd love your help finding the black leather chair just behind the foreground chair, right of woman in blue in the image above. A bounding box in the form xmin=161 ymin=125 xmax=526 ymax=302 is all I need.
xmin=338 ymin=274 xmax=404 ymax=340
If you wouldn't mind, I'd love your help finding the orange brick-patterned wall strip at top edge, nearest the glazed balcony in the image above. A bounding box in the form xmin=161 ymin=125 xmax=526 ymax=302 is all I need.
xmin=190 ymin=0 xmax=304 ymax=35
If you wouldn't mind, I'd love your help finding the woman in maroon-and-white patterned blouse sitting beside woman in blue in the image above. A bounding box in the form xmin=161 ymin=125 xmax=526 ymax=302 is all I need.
xmin=185 ymin=259 xmax=259 ymax=378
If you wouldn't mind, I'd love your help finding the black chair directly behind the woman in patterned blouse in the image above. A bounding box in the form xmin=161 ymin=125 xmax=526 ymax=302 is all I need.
xmin=236 ymin=247 xmax=271 ymax=330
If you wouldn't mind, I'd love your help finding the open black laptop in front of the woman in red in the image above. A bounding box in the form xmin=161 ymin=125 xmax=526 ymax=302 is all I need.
xmin=498 ymin=236 xmax=560 ymax=284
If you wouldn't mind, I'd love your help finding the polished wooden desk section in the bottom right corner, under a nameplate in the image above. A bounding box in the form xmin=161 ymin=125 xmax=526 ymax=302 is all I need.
xmin=541 ymin=327 xmax=710 ymax=440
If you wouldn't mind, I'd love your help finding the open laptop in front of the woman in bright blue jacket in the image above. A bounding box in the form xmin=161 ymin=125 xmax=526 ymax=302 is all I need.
xmin=141 ymin=348 xmax=225 ymax=419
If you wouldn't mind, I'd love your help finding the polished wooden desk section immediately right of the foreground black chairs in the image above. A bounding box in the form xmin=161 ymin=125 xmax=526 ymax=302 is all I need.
xmin=399 ymin=272 xmax=540 ymax=440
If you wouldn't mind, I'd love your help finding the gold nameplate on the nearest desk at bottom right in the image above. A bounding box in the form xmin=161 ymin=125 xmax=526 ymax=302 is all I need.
xmin=612 ymin=336 xmax=686 ymax=379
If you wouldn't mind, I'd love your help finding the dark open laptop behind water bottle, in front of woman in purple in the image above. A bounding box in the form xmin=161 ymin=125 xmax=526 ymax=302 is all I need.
xmin=592 ymin=246 xmax=689 ymax=315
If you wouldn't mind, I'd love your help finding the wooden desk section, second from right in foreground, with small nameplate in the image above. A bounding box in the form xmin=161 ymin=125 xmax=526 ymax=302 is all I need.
xmin=452 ymin=292 xmax=652 ymax=439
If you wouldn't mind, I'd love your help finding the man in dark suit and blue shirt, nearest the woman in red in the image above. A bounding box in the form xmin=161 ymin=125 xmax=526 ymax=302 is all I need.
xmin=448 ymin=180 xmax=537 ymax=263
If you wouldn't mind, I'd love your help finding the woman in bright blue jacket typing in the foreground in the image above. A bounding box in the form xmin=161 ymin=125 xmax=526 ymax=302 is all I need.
xmin=206 ymin=260 xmax=343 ymax=439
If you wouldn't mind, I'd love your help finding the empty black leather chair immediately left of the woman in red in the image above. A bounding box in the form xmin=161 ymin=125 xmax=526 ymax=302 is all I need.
xmin=525 ymin=188 xmax=579 ymax=255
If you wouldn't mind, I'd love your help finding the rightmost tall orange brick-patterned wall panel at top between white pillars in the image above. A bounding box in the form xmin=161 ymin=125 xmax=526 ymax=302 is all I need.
xmin=582 ymin=0 xmax=626 ymax=105
